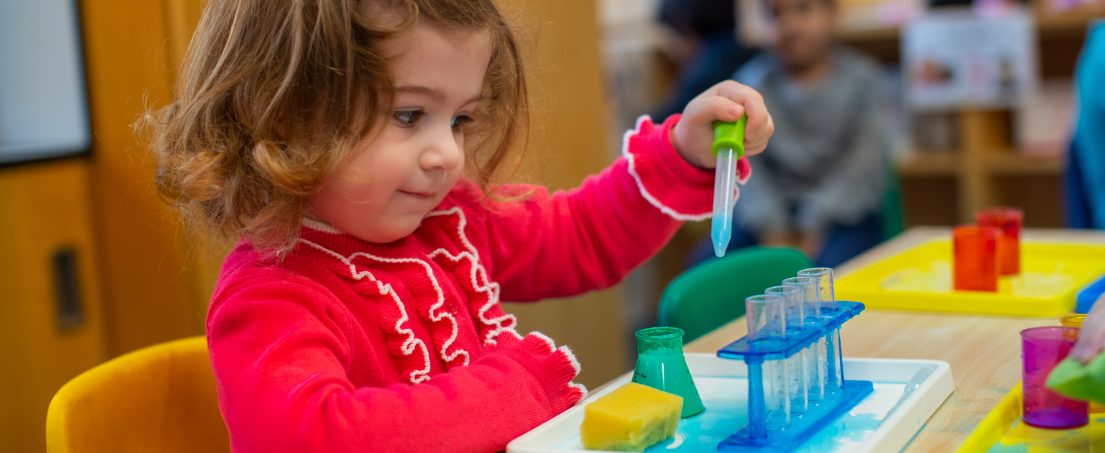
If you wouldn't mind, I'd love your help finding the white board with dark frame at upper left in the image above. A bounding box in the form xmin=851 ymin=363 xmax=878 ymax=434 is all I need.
xmin=0 ymin=0 xmax=91 ymax=165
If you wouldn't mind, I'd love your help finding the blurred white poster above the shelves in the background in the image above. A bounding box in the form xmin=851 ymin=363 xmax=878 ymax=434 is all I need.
xmin=902 ymin=10 xmax=1039 ymax=110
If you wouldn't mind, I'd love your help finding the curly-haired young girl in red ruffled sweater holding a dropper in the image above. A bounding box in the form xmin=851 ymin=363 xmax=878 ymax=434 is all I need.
xmin=154 ymin=0 xmax=772 ymax=452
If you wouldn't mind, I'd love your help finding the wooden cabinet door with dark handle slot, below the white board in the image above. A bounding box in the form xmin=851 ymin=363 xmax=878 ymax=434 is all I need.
xmin=0 ymin=158 xmax=106 ymax=452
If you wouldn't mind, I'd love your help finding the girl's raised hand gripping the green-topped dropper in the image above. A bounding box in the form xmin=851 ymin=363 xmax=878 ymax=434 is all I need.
xmin=671 ymin=81 xmax=775 ymax=168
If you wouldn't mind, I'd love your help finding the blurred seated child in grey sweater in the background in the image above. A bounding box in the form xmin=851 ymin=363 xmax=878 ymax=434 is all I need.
xmin=692 ymin=0 xmax=892 ymax=266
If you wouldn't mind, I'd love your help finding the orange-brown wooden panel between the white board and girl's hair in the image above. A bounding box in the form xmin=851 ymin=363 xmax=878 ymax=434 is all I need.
xmin=82 ymin=0 xmax=207 ymax=356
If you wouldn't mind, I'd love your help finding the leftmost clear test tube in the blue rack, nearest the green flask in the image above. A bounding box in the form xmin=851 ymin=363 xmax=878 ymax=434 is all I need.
xmin=745 ymin=294 xmax=790 ymax=425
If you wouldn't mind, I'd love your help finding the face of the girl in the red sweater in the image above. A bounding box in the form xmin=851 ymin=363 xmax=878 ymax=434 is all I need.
xmin=308 ymin=23 xmax=492 ymax=243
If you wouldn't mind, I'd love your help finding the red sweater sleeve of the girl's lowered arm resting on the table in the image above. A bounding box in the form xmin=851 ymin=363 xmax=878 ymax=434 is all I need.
xmin=208 ymin=272 xmax=582 ymax=453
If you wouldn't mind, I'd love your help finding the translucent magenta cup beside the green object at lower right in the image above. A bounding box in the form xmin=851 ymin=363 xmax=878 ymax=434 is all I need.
xmin=1021 ymin=326 xmax=1090 ymax=430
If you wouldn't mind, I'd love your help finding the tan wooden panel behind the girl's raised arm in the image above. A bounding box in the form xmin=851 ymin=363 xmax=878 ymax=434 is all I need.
xmin=499 ymin=0 xmax=631 ymax=387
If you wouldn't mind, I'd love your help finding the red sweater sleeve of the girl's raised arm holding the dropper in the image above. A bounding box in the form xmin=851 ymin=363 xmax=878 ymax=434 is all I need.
xmin=485 ymin=115 xmax=724 ymax=302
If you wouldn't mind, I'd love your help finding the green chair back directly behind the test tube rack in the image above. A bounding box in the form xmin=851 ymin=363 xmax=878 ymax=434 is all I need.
xmin=659 ymin=247 xmax=812 ymax=341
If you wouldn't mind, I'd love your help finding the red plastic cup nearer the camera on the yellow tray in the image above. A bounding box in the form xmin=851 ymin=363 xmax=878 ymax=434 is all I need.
xmin=951 ymin=225 xmax=1001 ymax=292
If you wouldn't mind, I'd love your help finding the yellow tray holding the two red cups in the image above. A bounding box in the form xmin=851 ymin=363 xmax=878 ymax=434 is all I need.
xmin=836 ymin=240 xmax=1105 ymax=317
